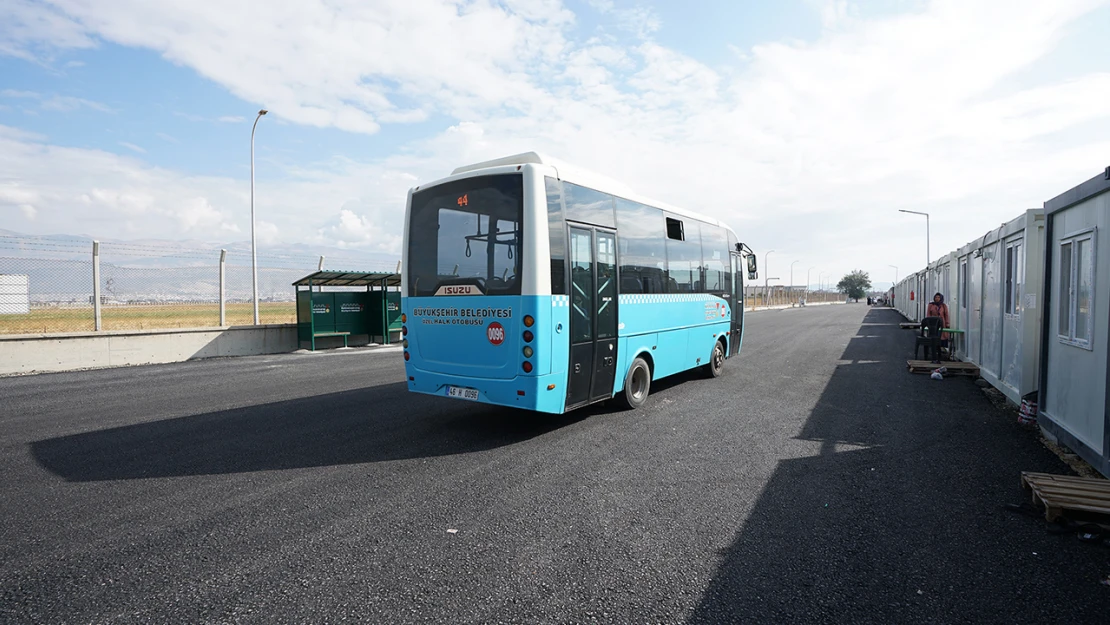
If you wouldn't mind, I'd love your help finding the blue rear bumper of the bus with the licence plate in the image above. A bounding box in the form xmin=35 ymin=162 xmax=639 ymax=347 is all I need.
xmin=405 ymin=366 xmax=566 ymax=414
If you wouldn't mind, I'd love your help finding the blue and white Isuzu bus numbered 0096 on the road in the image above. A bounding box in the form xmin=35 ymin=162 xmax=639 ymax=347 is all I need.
xmin=401 ymin=152 xmax=756 ymax=413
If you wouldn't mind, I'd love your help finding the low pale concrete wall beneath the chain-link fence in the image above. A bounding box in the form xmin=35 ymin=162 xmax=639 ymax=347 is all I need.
xmin=0 ymin=324 xmax=299 ymax=375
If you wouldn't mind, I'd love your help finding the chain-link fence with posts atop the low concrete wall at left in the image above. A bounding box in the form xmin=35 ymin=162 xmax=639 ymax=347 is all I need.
xmin=0 ymin=235 xmax=396 ymax=334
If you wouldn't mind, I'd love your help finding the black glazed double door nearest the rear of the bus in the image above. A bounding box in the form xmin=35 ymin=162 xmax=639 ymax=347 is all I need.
xmin=566 ymin=226 xmax=617 ymax=410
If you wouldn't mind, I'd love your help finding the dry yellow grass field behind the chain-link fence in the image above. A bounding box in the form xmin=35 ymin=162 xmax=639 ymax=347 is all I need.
xmin=0 ymin=302 xmax=296 ymax=334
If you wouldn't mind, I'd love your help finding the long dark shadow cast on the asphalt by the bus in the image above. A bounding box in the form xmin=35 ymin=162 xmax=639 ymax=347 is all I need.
xmin=30 ymin=383 xmax=606 ymax=482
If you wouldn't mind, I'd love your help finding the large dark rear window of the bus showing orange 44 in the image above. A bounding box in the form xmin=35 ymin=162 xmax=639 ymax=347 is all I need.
xmin=407 ymin=174 xmax=524 ymax=296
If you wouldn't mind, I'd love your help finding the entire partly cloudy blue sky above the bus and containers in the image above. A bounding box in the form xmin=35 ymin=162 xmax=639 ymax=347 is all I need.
xmin=0 ymin=0 xmax=1110 ymax=286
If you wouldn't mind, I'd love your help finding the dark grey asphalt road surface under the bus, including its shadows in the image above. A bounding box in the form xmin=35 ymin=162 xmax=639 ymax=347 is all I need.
xmin=0 ymin=304 xmax=1110 ymax=624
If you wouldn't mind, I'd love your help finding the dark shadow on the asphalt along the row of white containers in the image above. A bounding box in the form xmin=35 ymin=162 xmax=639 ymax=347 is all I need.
xmin=689 ymin=310 xmax=1110 ymax=624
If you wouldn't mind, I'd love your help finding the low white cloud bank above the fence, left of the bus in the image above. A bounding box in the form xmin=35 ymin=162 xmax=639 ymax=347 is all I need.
xmin=0 ymin=125 xmax=424 ymax=253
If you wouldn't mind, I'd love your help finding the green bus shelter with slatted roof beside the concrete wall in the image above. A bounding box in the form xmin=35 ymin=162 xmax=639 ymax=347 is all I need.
xmin=293 ymin=271 xmax=401 ymax=351
